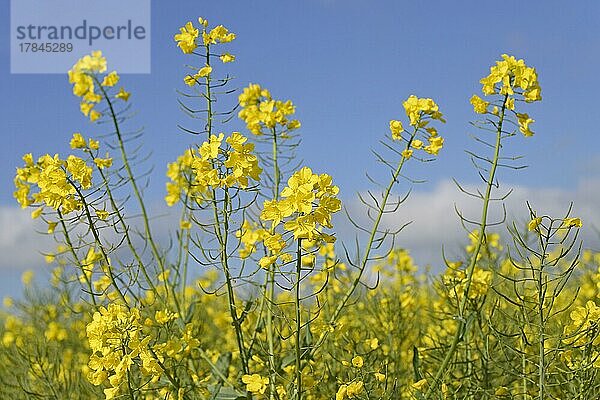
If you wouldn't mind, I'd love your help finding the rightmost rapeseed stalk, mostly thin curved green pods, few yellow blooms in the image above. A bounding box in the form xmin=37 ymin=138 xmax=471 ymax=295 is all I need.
xmin=490 ymin=208 xmax=584 ymax=400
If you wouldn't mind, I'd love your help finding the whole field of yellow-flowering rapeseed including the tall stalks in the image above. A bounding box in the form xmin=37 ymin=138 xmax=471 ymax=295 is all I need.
xmin=0 ymin=18 xmax=600 ymax=400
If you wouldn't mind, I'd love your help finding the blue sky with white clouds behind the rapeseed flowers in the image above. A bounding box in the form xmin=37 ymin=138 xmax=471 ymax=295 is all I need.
xmin=0 ymin=0 xmax=600 ymax=297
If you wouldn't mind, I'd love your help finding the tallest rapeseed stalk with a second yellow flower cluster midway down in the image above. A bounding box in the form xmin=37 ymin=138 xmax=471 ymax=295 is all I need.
xmin=166 ymin=18 xmax=262 ymax=386
